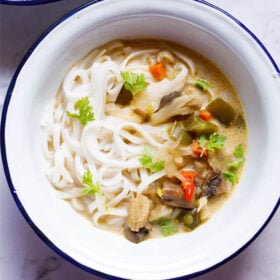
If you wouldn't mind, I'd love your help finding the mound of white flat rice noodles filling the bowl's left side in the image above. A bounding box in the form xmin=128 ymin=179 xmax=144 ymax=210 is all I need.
xmin=42 ymin=41 xmax=195 ymax=230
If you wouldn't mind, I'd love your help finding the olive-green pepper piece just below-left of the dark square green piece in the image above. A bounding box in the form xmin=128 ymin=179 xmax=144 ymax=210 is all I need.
xmin=183 ymin=115 xmax=218 ymax=136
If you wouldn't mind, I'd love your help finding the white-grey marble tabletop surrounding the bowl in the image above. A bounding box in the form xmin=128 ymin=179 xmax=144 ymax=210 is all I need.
xmin=0 ymin=0 xmax=280 ymax=280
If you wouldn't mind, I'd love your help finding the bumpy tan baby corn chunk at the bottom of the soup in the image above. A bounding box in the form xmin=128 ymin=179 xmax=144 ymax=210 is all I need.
xmin=127 ymin=194 xmax=151 ymax=232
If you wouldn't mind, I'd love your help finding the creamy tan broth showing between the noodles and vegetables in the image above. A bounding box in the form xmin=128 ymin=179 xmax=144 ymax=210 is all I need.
xmin=44 ymin=40 xmax=247 ymax=242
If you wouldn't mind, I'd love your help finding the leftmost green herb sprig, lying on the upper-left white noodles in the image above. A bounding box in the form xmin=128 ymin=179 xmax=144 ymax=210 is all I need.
xmin=66 ymin=97 xmax=94 ymax=126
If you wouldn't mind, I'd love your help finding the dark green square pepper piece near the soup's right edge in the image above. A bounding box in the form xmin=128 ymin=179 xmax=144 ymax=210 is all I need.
xmin=206 ymin=97 xmax=236 ymax=125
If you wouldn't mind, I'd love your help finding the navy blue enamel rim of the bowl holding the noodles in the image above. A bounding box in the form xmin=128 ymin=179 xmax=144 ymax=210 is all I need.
xmin=0 ymin=0 xmax=280 ymax=280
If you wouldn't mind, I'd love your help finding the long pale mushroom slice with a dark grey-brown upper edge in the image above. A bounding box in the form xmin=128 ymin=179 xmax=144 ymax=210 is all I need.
xmin=151 ymin=91 xmax=201 ymax=125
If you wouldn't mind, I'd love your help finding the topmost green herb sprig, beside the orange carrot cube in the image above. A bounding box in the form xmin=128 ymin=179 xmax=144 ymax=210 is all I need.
xmin=121 ymin=72 xmax=147 ymax=97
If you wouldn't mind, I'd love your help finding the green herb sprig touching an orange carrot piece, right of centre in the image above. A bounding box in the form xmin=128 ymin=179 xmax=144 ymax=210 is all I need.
xmin=197 ymin=132 xmax=226 ymax=154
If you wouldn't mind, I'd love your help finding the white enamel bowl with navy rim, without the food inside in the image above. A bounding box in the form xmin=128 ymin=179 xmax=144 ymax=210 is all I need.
xmin=1 ymin=0 xmax=280 ymax=279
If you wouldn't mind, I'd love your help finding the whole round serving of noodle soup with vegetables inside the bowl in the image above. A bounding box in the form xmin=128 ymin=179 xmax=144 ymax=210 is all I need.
xmin=42 ymin=40 xmax=247 ymax=243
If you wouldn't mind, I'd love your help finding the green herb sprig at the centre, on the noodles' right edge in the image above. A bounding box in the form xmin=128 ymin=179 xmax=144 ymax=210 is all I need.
xmin=139 ymin=146 xmax=165 ymax=173
